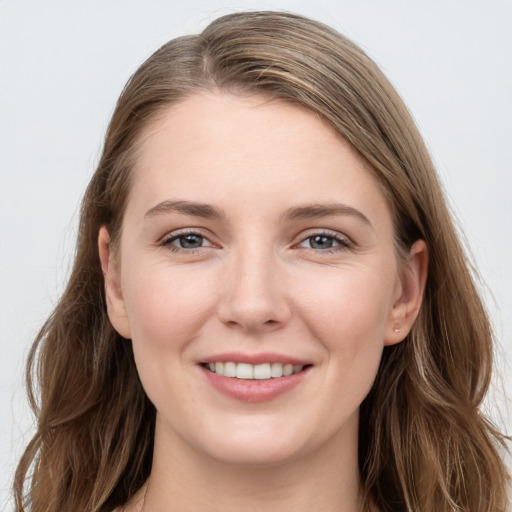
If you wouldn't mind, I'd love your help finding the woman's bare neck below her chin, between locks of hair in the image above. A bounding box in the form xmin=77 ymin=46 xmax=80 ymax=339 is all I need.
xmin=140 ymin=416 xmax=362 ymax=512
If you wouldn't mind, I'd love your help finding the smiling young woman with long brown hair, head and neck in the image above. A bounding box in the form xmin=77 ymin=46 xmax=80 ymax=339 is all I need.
xmin=15 ymin=12 xmax=508 ymax=512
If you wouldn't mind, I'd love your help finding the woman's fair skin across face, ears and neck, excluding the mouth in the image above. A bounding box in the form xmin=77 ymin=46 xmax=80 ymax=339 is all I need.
xmin=99 ymin=91 xmax=427 ymax=512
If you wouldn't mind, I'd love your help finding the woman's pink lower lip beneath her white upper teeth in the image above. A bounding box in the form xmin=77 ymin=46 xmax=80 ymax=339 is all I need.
xmin=201 ymin=366 xmax=311 ymax=403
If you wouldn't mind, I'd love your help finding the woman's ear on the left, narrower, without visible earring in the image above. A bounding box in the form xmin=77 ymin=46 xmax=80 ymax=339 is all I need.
xmin=98 ymin=226 xmax=131 ymax=339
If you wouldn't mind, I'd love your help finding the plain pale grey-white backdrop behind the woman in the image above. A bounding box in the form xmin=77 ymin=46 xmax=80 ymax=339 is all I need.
xmin=0 ymin=0 xmax=512 ymax=510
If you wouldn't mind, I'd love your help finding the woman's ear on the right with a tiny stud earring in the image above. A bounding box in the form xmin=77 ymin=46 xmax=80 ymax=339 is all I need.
xmin=384 ymin=240 xmax=428 ymax=345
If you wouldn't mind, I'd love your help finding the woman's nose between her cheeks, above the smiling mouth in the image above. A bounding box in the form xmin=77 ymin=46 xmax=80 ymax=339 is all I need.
xmin=218 ymin=247 xmax=291 ymax=334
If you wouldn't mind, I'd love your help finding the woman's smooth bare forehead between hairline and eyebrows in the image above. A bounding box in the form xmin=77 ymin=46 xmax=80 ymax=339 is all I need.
xmin=129 ymin=92 xmax=387 ymax=229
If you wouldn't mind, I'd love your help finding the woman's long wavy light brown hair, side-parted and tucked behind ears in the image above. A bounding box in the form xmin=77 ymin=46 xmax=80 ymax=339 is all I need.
xmin=14 ymin=12 xmax=509 ymax=512
